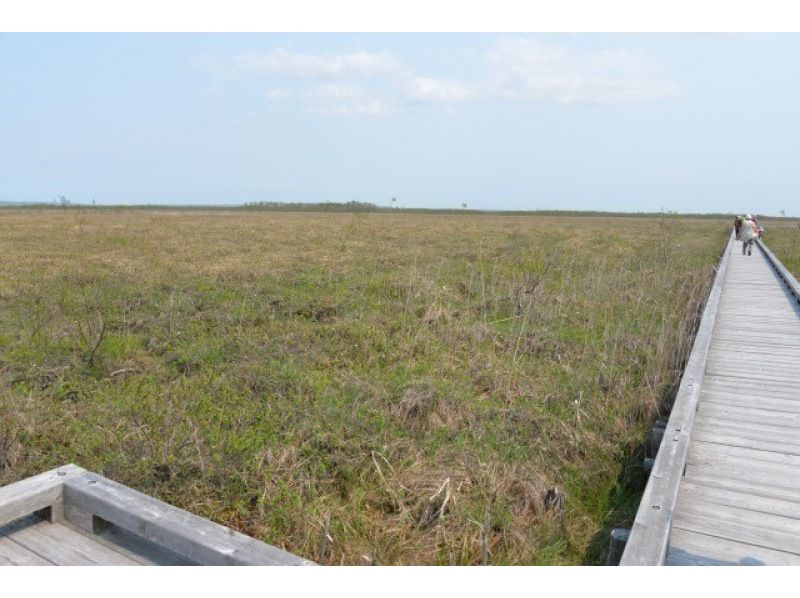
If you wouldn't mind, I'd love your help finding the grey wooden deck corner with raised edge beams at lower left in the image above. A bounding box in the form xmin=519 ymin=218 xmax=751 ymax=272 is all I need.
xmin=0 ymin=465 xmax=313 ymax=565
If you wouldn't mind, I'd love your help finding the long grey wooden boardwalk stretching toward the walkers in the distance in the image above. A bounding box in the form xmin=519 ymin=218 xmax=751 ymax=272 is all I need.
xmin=621 ymin=233 xmax=800 ymax=565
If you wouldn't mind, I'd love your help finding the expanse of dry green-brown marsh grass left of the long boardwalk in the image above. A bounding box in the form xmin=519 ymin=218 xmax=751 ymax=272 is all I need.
xmin=0 ymin=210 xmax=729 ymax=564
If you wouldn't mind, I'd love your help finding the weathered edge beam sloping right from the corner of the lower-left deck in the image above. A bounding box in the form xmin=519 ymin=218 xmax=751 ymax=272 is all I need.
xmin=64 ymin=472 xmax=313 ymax=565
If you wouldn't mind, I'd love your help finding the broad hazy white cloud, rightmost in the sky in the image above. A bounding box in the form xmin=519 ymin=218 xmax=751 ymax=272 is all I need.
xmin=486 ymin=38 xmax=679 ymax=104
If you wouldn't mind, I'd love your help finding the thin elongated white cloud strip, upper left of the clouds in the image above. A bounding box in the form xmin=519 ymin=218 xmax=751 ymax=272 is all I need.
xmin=234 ymin=48 xmax=399 ymax=78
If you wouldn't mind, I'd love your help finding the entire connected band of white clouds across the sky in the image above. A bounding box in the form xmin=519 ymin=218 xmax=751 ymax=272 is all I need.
xmin=214 ymin=37 xmax=680 ymax=116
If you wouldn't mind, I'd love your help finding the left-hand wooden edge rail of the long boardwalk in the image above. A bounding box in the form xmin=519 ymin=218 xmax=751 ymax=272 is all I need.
xmin=620 ymin=234 xmax=734 ymax=565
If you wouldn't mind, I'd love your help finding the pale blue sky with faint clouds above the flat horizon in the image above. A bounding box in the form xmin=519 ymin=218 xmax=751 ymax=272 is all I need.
xmin=0 ymin=33 xmax=800 ymax=216
